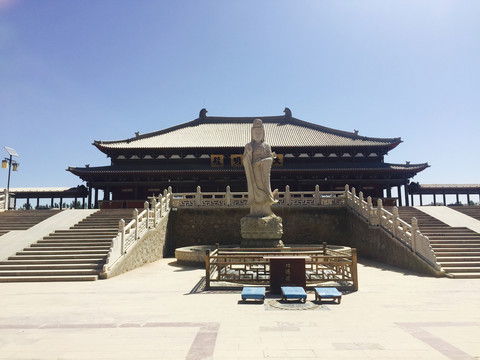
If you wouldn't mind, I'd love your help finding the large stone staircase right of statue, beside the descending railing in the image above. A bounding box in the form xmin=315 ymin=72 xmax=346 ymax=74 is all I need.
xmin=398 ymin=207 xmax=480 ymax=279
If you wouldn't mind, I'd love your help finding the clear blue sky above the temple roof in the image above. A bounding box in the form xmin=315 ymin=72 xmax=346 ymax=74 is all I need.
xmin=0 ymin=0 xmax=480 ymax=187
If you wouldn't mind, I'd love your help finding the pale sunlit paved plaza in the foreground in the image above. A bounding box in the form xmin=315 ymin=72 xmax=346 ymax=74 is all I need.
xmin=0 ymin=259 xmax=480 ymax=360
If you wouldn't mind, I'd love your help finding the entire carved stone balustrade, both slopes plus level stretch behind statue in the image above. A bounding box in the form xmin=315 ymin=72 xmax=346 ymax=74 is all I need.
xmin=104 ymin=185 xmax=440 ymax=271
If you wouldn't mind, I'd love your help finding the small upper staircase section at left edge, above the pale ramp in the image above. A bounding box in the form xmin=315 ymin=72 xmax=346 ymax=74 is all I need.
xmin=0 ymin=210 xmax=60 ymax=236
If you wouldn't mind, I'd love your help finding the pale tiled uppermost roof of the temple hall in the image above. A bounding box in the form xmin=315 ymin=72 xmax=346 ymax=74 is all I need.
xmin=94 ymin=116 xmax=401 ymax=150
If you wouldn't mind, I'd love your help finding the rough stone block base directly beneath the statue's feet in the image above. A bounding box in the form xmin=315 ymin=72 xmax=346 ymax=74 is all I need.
xmin=240 ymin=214 xmax=283 ymax=248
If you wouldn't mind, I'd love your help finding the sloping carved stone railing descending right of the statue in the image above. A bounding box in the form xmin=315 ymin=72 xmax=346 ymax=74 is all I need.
xmin=345 ymin=185 xmax=441 ymax=270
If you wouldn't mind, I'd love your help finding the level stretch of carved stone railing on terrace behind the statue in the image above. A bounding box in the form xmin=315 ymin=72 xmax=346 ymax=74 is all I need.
xmin=172 ymin=185 xmax=345 ymax=208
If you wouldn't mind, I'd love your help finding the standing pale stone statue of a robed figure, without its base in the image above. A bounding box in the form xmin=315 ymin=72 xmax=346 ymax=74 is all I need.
xmin=243 ymin=119 xmax=276 ymax=217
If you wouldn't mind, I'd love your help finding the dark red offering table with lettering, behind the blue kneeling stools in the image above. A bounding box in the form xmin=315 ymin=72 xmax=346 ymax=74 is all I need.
xmin=264 ymin=255 xmax=310 ymax=294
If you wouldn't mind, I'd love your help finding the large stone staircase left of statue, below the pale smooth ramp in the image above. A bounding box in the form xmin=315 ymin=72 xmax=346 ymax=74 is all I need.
xmin=0 ymin=209 xmax=132 ymax=282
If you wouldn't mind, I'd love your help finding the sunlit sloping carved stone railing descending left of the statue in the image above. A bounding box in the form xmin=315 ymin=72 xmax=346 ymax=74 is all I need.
xmin=103 ymin=189 xmax=172 ymax=273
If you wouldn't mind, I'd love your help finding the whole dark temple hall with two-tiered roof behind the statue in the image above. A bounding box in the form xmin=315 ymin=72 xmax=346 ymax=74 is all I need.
xmin=67 ymin=108 xmax=429 ymax=206
